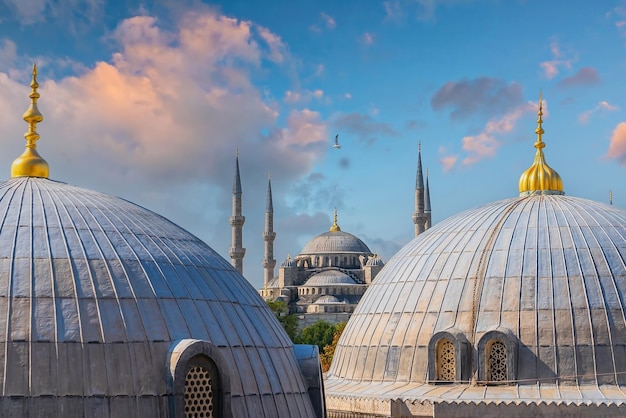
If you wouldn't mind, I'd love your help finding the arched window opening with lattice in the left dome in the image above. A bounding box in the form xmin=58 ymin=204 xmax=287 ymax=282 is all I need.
xmin=185 ymin=358 xmax=221 ymax=418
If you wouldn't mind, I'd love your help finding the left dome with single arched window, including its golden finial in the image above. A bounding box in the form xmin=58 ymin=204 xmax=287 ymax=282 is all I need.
xmin=0 ymin=66 xmax=318 ymax=417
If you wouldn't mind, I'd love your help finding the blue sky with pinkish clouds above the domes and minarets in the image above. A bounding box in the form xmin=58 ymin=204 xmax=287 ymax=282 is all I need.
xmin=0 ymin=0 xmax=626 ymax=287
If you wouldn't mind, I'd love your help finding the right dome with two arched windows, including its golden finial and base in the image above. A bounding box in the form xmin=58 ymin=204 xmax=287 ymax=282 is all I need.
xmin=326 ymin=96 xmax=626 ymax=417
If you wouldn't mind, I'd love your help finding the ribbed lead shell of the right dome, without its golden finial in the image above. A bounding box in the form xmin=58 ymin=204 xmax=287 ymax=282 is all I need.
xmin=327 ymin=195 xmax=626 ymax=386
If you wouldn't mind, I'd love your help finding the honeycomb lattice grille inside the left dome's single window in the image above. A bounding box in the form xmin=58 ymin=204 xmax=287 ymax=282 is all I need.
xmin=185 ymin=366 xmax=215 ymax=418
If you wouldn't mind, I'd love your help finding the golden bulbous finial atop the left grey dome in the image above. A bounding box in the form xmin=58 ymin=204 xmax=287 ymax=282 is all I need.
xmin=11 ymin=63 xmax=50 ymax=178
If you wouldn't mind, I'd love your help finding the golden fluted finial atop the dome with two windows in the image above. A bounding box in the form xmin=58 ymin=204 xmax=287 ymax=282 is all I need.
xmin=519 ymin=92 xmax=565 ymax=196
